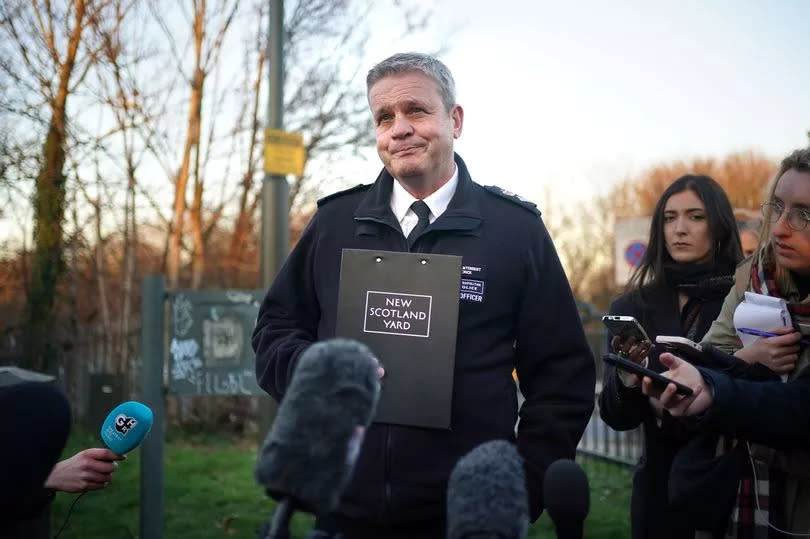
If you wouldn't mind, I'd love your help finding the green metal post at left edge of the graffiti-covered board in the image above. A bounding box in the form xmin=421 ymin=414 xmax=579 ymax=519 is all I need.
xmin=139 ymin=275 xmax=166 ymax=539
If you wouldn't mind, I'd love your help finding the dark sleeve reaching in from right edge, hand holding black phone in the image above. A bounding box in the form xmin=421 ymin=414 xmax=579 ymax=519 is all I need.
xmin=700 ymin=369 xmax=810 ymax=449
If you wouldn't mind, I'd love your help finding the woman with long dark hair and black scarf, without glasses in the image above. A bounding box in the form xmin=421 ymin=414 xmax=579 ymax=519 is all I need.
xmin=599 ymin=175 xmax=742 ymax=539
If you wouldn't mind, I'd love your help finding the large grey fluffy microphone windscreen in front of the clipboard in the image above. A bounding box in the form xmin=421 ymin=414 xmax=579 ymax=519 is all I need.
xmin=256 ymin=339 xmax=380 ymax=514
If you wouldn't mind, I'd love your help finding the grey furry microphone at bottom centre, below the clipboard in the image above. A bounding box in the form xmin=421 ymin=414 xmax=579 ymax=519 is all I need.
xmin=447 ymin=440 xmax=529 ymax=539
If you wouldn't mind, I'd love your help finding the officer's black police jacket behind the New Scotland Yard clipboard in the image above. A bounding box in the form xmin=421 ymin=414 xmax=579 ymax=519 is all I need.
xmin=253 ymin=156 xmax=595 ymax=523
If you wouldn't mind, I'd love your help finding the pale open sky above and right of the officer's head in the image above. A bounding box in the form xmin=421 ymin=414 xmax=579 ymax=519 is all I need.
xmin=358 ymin=0 xmax=810 ymax=208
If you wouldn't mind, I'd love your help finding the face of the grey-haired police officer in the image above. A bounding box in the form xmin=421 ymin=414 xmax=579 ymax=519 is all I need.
xmin=369 ymin=71 xmax=464 ymax=188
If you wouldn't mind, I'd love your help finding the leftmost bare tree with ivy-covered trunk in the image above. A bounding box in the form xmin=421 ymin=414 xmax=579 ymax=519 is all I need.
xmin=0 ymin=0 xmax=115 ymax=370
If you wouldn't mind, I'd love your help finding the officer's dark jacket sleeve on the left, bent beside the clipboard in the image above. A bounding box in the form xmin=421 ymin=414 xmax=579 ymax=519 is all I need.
xmin=252 ymin=213 xmax=321 ymax=401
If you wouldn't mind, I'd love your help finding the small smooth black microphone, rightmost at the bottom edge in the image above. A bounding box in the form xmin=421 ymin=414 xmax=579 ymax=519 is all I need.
xmin=543 ymin=459 xmax=591 ymax=539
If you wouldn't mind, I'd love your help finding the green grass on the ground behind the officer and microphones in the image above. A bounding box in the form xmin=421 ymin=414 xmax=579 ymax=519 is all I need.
xmin=51 ymin=432 xmax=631 ymax=539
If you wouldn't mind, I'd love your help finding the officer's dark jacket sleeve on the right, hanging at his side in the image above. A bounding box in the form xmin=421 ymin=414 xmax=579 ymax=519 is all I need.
xmin=515 ymin=221 xmax=595 ymax=520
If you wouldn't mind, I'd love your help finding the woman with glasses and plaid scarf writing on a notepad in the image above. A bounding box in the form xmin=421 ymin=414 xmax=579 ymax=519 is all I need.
xmin=664 ymin=148 xmax=810 ymax=537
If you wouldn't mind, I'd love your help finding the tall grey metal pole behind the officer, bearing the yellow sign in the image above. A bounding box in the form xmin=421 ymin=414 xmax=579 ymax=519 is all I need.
xmin=261 ymin=0 xmax=290 ymax=288
